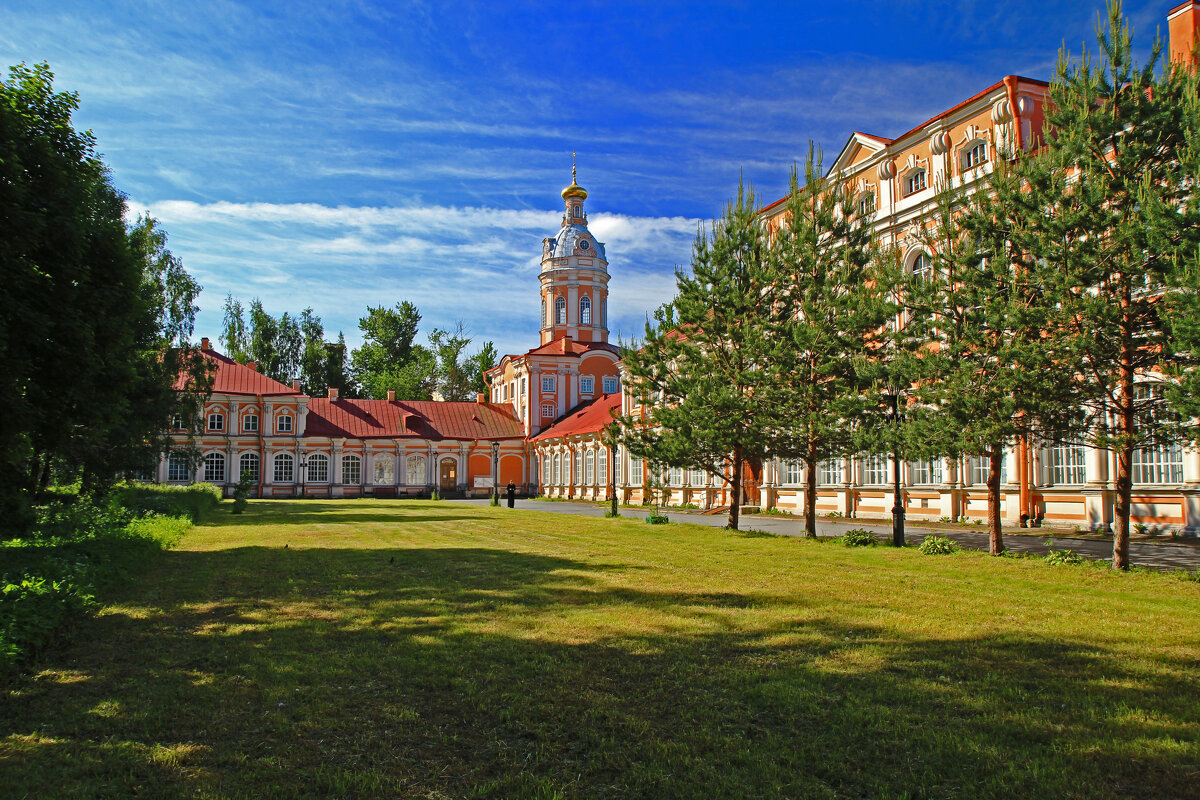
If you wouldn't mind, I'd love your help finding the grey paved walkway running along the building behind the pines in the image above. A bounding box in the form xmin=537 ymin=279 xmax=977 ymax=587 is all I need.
xmin=456 ymin=499 xmax=1200 ymax=570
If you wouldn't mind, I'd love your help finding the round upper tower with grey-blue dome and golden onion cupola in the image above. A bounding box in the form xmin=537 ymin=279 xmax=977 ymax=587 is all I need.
xmin=538 ymin=152 xmax=608 ymax=344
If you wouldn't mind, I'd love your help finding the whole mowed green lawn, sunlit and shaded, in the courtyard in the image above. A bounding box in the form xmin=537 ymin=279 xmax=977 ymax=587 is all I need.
xmin=0 ymin=500 xmax=1200 ymax=800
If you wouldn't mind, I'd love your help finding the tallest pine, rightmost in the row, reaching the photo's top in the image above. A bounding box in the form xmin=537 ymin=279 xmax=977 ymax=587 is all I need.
xmin=997 ymin=2 xmax=1200 ymax=570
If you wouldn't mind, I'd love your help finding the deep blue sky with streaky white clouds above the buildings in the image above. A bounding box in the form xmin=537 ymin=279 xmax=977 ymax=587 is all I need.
xmin=0 ymin=0 xmax=1176 ymax=351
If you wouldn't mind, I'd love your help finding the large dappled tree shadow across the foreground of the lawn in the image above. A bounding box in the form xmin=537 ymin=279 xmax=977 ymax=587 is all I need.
xmin=0 ymin=548 xmax=1200 ymax=798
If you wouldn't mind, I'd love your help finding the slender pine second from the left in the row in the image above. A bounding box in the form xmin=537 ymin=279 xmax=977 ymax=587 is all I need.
xmin=762 ymin=144 xmax=895 ymax=536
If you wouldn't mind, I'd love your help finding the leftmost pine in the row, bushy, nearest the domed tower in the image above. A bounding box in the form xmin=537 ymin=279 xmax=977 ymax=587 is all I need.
xmin=620 ymin=185 xmax=779 ymax=529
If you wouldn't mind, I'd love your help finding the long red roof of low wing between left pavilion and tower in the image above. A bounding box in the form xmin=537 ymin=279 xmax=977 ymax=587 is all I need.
xmin=305 ymin=397 xmax=524 ymax=440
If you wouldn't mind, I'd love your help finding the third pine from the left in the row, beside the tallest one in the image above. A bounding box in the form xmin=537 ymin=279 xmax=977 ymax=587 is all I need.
xmin=901 ymin=169 xmax=1078 ymax=555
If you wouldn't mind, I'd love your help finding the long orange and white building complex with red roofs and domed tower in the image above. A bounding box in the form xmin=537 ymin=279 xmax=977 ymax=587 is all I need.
xmin=154 ymin=0 xmax=1200 ymax=533
